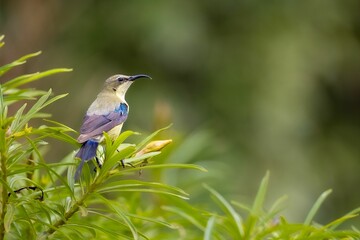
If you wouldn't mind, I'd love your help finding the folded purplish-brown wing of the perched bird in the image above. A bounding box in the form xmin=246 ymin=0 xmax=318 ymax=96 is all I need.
xmin=77 ymin=111 xmax=127 ymax=143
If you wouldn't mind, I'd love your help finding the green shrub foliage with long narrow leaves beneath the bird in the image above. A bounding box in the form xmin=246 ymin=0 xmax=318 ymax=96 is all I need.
xmin=0 ymin=36 xmax=360 ymax=240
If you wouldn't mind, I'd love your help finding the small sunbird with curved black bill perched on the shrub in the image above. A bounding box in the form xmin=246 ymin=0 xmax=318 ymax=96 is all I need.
xmin=75 ymin=74 xmax=151 ymax=179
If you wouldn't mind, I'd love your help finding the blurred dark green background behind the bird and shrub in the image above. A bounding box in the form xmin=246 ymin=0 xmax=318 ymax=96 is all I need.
xmin=0 ymin=0 xmax=360 ymax=225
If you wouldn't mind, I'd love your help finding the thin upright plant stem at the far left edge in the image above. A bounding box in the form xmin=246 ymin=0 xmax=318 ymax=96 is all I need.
xmin=0 ymin=152 xmax=9 ymax=240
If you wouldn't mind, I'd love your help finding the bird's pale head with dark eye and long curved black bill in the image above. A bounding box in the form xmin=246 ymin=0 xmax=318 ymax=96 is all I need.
xmin=104 ymin=74 xmax=151 ymax=99
